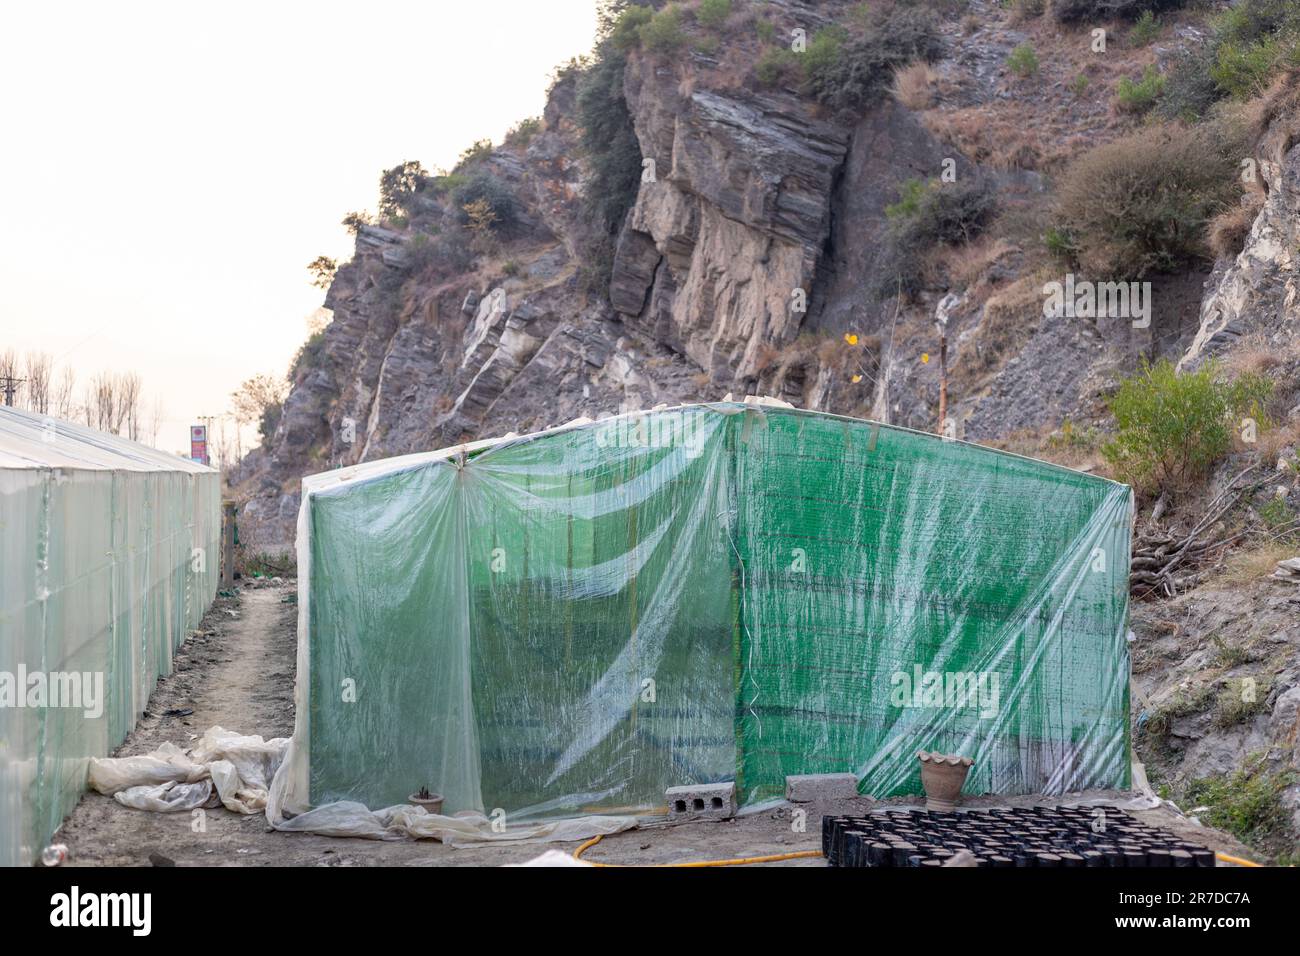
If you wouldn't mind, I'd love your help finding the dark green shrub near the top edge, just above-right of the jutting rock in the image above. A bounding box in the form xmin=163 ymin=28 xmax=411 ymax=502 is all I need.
xmin=802 ymin=7 xmax=944 ymax=111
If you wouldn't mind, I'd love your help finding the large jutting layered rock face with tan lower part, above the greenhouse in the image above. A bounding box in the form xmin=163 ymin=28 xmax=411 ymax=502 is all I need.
xmin=610 ymin=57 xmax=849 ymax=388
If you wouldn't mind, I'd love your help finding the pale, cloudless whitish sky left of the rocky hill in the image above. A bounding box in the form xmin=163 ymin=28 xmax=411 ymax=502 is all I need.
xmin=0 ymin=0 xmax=595 ymax=451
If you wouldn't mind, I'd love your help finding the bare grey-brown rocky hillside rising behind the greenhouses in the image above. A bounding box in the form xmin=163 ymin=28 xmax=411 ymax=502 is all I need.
xmin=241 ymin=0 xmax=1300 ymax=858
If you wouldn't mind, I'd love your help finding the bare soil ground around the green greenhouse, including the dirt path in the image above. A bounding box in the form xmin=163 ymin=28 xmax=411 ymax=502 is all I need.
xmin=56 ymin=581 xmax=1253 ymax=866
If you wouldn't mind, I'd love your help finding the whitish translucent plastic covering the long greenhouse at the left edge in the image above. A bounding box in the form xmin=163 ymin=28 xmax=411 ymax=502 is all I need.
xmin=0 ymin=407 xmax=221 ymax=865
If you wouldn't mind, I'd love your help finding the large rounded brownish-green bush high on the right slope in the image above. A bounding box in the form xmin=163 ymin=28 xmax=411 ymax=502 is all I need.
xmin=1057 ymin=120 xmax=1248 ymax=280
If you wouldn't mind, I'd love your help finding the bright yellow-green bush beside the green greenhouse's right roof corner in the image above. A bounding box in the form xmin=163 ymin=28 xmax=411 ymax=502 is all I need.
xmin=1101 ymin=359 xmax=1273 ymax=493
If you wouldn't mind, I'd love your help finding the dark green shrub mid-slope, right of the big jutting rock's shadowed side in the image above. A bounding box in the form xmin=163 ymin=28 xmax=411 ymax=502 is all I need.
xmin=871 ymin=179 xmax=996 ymax=298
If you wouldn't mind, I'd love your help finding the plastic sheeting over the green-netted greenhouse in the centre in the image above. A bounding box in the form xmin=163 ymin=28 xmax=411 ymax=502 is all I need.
xmin=287 ymin=405 xmax=1131 ymax=819
